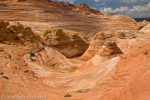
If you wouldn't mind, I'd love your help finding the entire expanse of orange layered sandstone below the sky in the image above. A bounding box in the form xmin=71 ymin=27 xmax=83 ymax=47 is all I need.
xmin=0 ymin=0 xmax=150 ymax=100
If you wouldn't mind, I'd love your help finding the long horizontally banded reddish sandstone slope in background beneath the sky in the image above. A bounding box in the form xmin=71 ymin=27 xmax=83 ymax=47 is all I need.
xmin=0 ymin=0 xmax=139 ymax=35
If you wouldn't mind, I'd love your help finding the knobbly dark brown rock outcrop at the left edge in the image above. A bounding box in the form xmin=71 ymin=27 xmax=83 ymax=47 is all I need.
xmin=0 ymin=19 xmax=41 ymax=45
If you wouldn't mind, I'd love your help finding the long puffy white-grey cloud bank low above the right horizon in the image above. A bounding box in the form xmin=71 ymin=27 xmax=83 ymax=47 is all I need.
xmin=100 ymin=2 xmax=150 ymax=18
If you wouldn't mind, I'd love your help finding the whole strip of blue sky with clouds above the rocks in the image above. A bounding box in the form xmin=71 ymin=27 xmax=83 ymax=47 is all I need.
xmin=52 ymin=0 xmax=150 ymax=18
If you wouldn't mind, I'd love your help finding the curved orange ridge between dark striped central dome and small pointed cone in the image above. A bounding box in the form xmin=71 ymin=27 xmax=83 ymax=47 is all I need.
xmin=80 ymin=29 xmax=125 ymax=61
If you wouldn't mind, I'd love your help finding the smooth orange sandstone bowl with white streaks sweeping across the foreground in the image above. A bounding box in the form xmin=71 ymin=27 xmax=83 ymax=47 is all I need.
xmin=0 ymin=40 xmax=150 ymax=100
